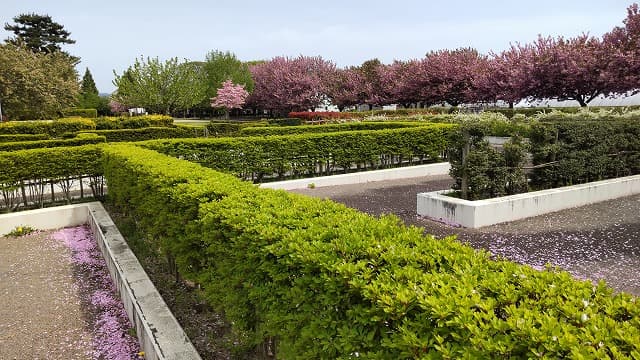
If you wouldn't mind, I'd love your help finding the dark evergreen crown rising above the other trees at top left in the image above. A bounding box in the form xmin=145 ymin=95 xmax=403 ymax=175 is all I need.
xmin=4 ymin=13 xmax=75 ymax=54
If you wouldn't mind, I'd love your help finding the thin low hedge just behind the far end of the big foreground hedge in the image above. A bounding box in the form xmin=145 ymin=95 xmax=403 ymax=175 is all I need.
xmin=82 ymin=126 xmax=203 ymax=142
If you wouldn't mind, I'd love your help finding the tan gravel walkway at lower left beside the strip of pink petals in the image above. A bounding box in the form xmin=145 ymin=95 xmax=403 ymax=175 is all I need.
xmin=0 ymin=232 xmax=92 ymax=360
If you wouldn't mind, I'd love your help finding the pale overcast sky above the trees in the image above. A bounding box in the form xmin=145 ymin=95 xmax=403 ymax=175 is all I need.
xmin=0 ymin=0 xmax=632 ymax=92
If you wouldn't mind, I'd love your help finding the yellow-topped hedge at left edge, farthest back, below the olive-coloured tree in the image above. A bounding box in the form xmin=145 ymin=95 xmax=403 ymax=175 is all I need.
xmin=0 ymin=118 xmax=96 ymax=137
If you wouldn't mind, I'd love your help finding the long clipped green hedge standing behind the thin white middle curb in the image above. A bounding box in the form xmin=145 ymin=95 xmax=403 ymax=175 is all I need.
xmin=142 ymin=124 xmax=456 ymax=182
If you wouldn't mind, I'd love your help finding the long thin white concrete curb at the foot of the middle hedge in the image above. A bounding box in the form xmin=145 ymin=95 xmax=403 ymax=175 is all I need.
xmin=260 ymin=162 xmax=451 ymax=190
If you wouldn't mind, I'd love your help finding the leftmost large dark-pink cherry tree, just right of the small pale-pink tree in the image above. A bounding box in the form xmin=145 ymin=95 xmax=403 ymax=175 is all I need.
xmin=248 ymin=56 xmax=336 ymax=115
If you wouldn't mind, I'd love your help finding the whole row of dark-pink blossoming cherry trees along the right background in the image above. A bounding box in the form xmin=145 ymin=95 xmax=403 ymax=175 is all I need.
xmin=248 ymin=4 xmax=640 ymax=113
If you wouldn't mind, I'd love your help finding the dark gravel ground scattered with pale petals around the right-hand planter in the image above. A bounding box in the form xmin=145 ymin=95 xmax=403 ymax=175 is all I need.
xmin=294 ymin=176 xmax=640 ymax=295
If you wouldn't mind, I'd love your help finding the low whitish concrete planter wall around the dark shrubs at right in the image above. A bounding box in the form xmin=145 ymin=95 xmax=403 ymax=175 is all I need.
xmin=417 ymin=175 xmax=640 ymax=228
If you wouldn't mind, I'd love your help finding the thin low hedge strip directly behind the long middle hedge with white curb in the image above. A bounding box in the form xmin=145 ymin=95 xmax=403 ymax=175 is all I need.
xmin=239 ymin=121 xmax=429 ymax=136
